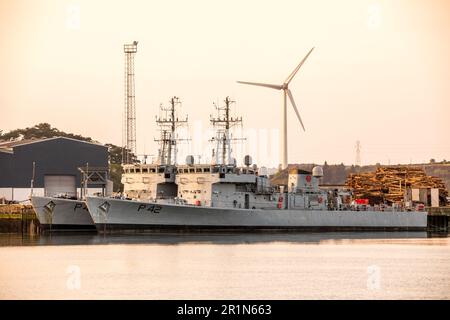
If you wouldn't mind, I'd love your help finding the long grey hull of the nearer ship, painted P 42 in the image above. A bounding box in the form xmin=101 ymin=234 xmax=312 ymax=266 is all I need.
xmin=86 ymin=197 xmax=427 ymax=232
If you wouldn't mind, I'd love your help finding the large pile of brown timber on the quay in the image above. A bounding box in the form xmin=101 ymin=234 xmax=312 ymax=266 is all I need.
xmin=345 ymin=166 xmax=448 ymax=204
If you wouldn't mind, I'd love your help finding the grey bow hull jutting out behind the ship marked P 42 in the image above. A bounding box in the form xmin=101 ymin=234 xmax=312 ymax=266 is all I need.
xmin=31 ymin=197 xmax=96 ymax=231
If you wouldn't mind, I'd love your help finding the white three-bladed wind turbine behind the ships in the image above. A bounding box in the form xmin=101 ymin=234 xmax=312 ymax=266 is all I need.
xmin=237 ymin=47 xmax=314 ymax=169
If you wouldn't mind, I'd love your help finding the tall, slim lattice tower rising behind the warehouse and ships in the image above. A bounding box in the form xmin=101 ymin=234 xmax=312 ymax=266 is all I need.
xmin=122 ymin=41 xmax=138 ymax=164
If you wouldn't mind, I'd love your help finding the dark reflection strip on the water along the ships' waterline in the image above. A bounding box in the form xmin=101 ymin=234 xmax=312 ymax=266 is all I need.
xmin=0 ymin=231 xmax=430 ymax=247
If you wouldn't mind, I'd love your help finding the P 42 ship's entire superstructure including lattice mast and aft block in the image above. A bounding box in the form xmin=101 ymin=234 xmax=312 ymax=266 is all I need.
xmin=175 ymin=97 xmax=327 ymax=209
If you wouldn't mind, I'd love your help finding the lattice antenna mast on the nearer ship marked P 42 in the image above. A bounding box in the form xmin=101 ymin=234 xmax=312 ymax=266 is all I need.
xmin=210 ymin=97 xmax=245 ymax=164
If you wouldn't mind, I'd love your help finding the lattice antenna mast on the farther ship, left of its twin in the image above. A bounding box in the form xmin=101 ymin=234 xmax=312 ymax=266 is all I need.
xmin=155 ymin=97 xmax=189 ymax=165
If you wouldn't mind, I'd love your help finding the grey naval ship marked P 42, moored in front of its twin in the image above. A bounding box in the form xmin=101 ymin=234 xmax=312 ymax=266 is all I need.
xmin=86 ymin=98 xmax=427 ymax=232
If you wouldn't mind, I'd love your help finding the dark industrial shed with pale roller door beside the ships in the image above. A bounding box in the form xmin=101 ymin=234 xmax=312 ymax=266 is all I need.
xmin=0 ymin=137 xmax=111 ymax=201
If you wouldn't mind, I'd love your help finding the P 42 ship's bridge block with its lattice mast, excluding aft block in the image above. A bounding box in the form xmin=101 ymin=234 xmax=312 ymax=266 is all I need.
xmin=175 ymin=97 xmax=306 ymax=209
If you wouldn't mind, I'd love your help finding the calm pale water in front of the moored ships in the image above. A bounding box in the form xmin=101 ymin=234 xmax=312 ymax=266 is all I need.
xmin=0 ymin=232 xmax=450 ymax=299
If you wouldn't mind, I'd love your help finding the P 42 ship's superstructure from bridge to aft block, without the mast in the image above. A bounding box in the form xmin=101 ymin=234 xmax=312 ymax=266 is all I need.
xmin=176 ymin=162 xmax=328 ymax=210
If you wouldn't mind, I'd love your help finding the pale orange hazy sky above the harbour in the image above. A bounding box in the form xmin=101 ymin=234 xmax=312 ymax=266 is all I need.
xmin=0 ymin=0 xmax=450 ymax=166
